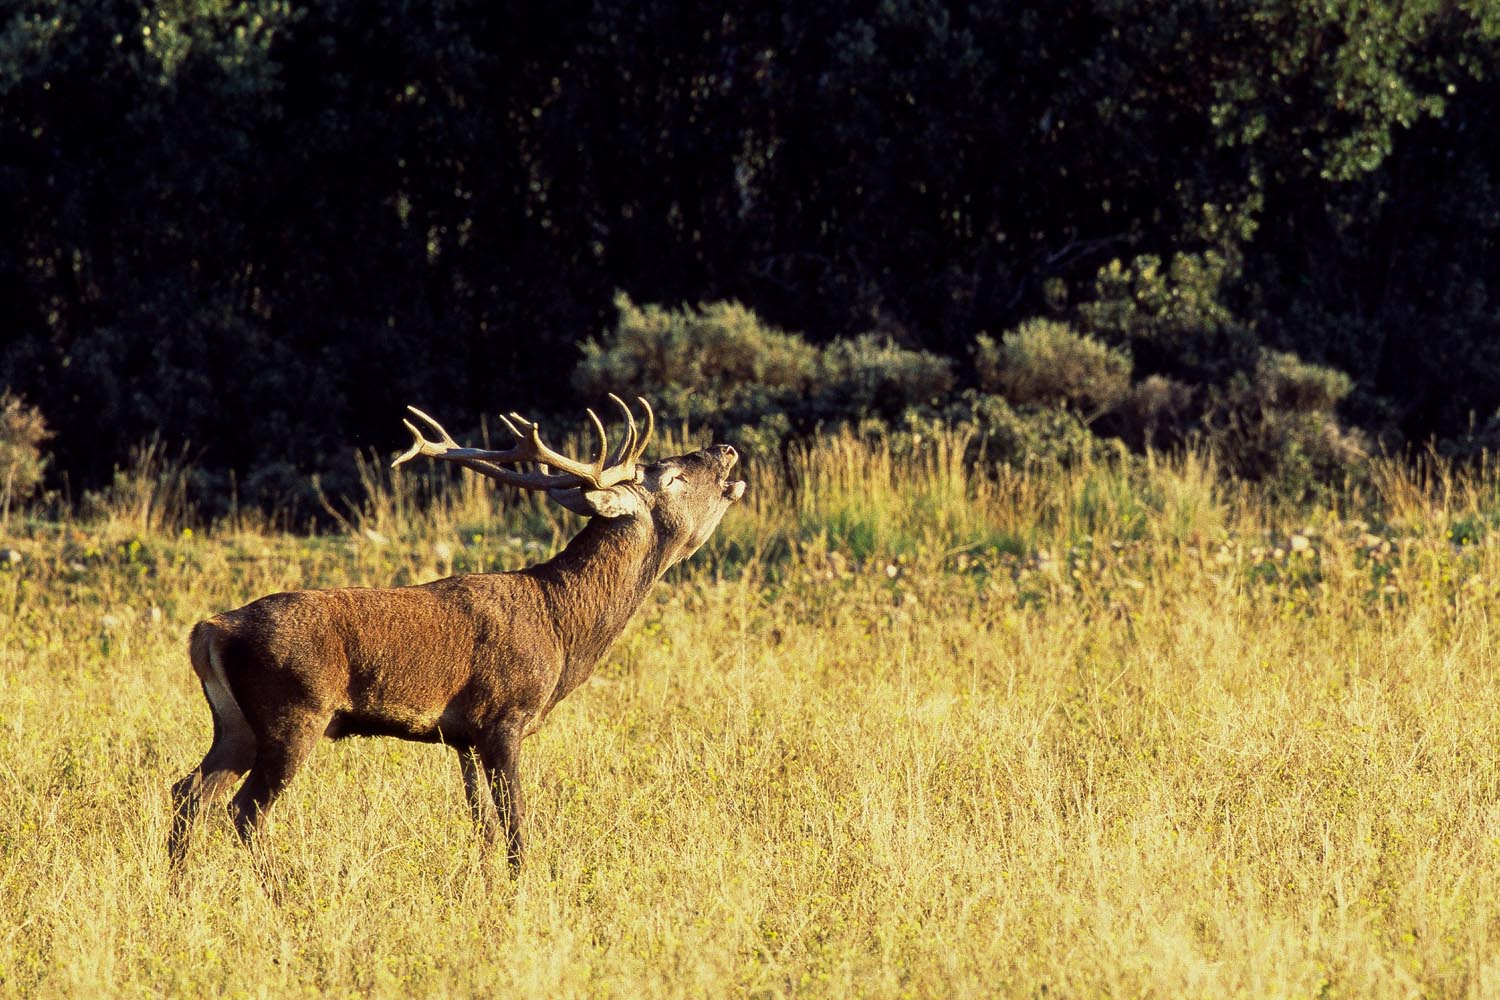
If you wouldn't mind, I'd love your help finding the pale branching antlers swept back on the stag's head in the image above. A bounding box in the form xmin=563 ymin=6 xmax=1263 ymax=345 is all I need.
xmin=392 ymin=393 xmax=656 ymax=490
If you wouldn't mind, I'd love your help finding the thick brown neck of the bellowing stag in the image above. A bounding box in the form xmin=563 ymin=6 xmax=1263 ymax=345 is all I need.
xmin=530 ymin=517 xmax=668 ymax=697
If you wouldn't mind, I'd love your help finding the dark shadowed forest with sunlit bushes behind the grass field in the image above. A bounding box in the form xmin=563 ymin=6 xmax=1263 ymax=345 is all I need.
xmin=0 ymin=0 xmax=1500 ymax=504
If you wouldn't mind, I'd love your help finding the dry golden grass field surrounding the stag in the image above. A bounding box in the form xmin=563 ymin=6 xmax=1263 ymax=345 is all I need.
xmin=0 ymin=439 xmax=1500 ymax=999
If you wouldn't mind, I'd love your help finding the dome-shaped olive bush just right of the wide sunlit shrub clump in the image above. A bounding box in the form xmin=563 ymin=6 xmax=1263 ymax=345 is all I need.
xmin=974 ymin=319 xmax=1131 ymax=414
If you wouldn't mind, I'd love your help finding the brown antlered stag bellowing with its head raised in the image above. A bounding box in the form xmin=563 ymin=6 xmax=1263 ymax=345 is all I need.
xmin=168 ymin=394 xmax=746 ymax=874
